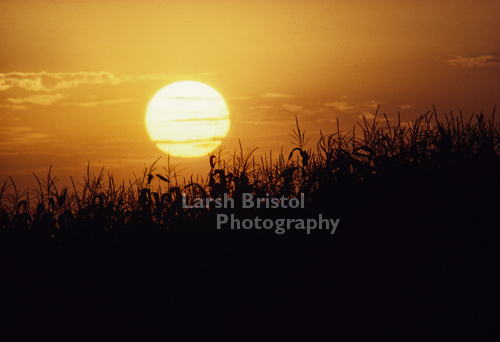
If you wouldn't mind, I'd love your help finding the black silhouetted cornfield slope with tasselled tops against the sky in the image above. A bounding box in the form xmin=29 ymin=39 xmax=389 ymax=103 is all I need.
xmin=0 ymin=110 xmax=500 ymax=340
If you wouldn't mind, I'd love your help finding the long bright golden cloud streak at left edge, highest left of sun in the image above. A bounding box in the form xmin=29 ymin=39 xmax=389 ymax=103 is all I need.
xmin=0 ymin=71 xmax=125 ymax=92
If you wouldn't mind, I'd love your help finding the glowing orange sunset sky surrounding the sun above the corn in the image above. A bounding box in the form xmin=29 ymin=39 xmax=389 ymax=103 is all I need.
xmin=0 ymin=1 xmax=500 ymax=188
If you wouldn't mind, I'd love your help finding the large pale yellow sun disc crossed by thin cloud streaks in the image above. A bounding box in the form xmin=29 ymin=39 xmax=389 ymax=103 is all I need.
xmin=146 ymin=81 xmax=230 ymax=158
